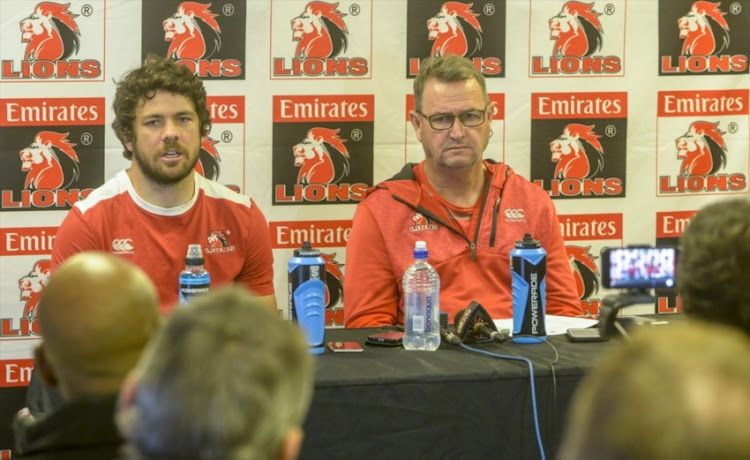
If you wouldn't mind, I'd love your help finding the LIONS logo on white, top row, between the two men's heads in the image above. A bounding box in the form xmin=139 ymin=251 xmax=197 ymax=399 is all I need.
xmin=271 ymin=1 xmax=372 ymax=78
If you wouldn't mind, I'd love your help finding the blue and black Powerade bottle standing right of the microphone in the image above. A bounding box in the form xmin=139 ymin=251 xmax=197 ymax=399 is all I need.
xmin=510 ymin=233 xmax=547 ymax=343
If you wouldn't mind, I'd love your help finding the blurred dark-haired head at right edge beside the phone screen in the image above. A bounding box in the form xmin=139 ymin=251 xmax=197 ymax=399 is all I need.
xmin=677 ymin=198 xmax=750 ymax=333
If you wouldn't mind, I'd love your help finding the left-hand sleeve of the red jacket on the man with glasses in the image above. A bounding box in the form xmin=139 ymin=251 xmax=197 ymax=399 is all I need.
xmin=344 ymin=202 xmax=399 ymax=328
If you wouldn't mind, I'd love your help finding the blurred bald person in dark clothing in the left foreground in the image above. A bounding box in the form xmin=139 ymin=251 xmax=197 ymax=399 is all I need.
xmin=13 ymin=252 xmax=160 ymax=460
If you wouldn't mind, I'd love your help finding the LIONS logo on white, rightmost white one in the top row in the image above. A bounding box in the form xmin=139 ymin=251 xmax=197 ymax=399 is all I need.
xmin=531 ymin=1 xmax=624 ymax=76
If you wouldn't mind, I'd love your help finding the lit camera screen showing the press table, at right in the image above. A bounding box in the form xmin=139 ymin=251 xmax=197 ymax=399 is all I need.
xmin=602 ymin=247 xmax=676 ymax=289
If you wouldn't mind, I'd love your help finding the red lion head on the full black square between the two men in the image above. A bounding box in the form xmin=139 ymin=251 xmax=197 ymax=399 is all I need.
xmin=292 ymin=128 xmax=349 ymax=184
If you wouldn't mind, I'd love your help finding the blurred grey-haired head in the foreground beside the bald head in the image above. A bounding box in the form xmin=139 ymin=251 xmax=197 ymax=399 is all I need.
xmin=117 ymin=287 xmax=312 ymax=460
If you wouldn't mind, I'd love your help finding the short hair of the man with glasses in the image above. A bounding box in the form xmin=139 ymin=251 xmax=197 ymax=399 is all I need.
xmin=414 ymin=54 xmax=490 ymax=111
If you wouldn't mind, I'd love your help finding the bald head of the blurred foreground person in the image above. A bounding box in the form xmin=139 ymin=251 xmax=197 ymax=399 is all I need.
xmin=39 ymin=252 xmax=159 ymax=399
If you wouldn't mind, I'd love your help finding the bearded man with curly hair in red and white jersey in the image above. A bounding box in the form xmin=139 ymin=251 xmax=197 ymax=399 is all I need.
xmin=52 ymin=56 xmax=276 ymax=313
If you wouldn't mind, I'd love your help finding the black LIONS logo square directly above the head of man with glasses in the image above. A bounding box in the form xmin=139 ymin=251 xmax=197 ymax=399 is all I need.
xmin=406 ymin=0 xmax=505 ymax=78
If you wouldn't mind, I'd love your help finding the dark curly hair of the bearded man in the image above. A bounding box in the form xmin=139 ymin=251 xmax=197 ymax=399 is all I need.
xmin=112 ymin=55 xmax=211 ymax=160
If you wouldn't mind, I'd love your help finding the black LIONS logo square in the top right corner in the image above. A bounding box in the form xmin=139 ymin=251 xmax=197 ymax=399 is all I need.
xmin=659 ymin=0 xmax=750 ymax=75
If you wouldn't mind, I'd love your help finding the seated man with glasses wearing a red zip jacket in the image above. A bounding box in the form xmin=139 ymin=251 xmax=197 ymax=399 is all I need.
xmin=344 ymin=55 xmax=581 ymax=327
